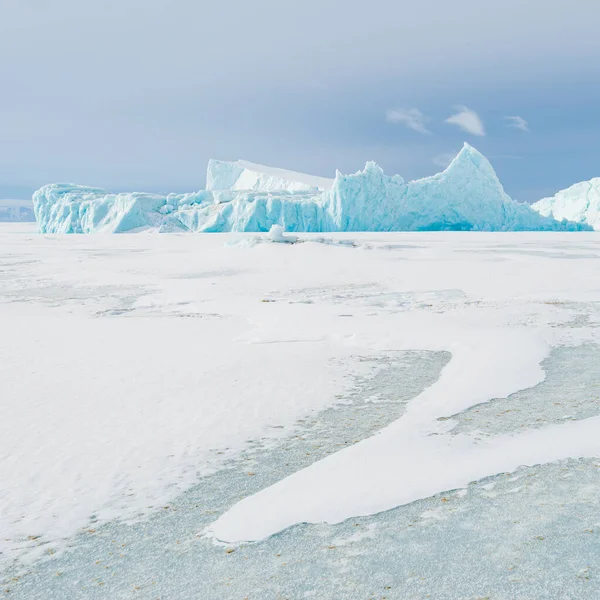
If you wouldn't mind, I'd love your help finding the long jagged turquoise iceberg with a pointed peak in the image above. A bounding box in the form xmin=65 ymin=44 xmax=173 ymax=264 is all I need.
xmin=33 ymin=144 xmax=591 ymax=233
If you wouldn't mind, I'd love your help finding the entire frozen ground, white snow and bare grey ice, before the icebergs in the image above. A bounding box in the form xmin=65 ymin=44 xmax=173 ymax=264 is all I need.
xmin=0 ymin=224 xmax=600 ymax=600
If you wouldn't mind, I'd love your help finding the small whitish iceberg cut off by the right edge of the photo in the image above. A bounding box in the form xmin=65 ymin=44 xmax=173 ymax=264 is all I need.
xmin=531 ymin=177 xmax=600 ymax=231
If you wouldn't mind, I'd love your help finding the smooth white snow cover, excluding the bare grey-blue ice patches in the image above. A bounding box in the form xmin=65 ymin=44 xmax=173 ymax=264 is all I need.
xmin=0 ymin=225 xmax=600 ymax=561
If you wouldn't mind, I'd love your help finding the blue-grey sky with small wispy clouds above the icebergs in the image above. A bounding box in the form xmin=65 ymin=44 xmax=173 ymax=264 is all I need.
xmin=0 ymin=0 xmax=600 ymax=200
